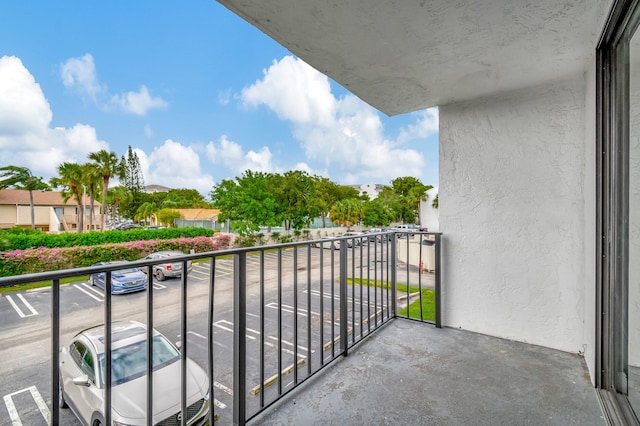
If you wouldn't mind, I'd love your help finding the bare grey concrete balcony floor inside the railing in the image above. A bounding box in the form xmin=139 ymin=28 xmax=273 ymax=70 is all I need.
xmin=250 ymin=319 xmax=606 ymax=425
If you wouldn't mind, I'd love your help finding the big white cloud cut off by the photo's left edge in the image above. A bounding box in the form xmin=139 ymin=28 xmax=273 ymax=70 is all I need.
xmin=0 ymin=56 xmax=108 ymax=178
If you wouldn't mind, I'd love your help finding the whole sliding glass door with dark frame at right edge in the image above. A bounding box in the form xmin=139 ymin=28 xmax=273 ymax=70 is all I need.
xmin=596 ymin=0 xmax=640 ymax=424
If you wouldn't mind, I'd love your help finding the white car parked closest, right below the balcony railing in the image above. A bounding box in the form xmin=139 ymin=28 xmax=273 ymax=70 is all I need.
xmin=58 ymin=321 xmax=210 ymax=425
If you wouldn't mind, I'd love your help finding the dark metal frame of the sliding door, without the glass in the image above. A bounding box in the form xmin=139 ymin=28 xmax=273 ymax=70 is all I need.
xmin=595 ymin=0 xmax=640 ymax=424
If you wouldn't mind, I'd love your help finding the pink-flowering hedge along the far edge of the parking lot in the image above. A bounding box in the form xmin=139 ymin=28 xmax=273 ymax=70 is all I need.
xmin=0 ymin=231 xmax=230 ymax=277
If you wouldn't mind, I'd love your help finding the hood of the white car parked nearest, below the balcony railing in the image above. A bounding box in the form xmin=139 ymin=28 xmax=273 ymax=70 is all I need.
xmin=111 ymin=359 xmax=209 ymax=424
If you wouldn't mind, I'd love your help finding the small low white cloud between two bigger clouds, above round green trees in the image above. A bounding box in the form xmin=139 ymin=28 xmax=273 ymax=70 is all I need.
xmin=206 ymin=135 xmax=281 ymax=175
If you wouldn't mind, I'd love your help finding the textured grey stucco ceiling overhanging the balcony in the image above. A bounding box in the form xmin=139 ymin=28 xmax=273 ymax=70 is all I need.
xmin=219 ymin=0 xmax=611 ymax=115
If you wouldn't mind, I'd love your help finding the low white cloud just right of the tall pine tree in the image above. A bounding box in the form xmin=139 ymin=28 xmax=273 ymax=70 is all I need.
xmin=139 ymin=139 xmax=213 ymax=196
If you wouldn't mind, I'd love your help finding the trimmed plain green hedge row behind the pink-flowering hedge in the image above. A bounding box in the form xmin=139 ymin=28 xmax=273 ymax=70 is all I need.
xmin=2 ymin=228 xmax=213 ymax=250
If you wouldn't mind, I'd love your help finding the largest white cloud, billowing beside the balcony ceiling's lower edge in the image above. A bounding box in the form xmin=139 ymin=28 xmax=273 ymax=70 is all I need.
xmin=242 ymin=56 xmax=424 ymax=182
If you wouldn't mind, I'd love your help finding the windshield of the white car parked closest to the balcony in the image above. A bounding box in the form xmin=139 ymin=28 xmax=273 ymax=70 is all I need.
xmin=99 ymin=336 xmax=180 ymax=386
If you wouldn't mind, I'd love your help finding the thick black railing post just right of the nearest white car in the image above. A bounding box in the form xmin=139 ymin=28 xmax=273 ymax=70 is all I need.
xmin=233 ymin=252 xmax=247 ymax=426
